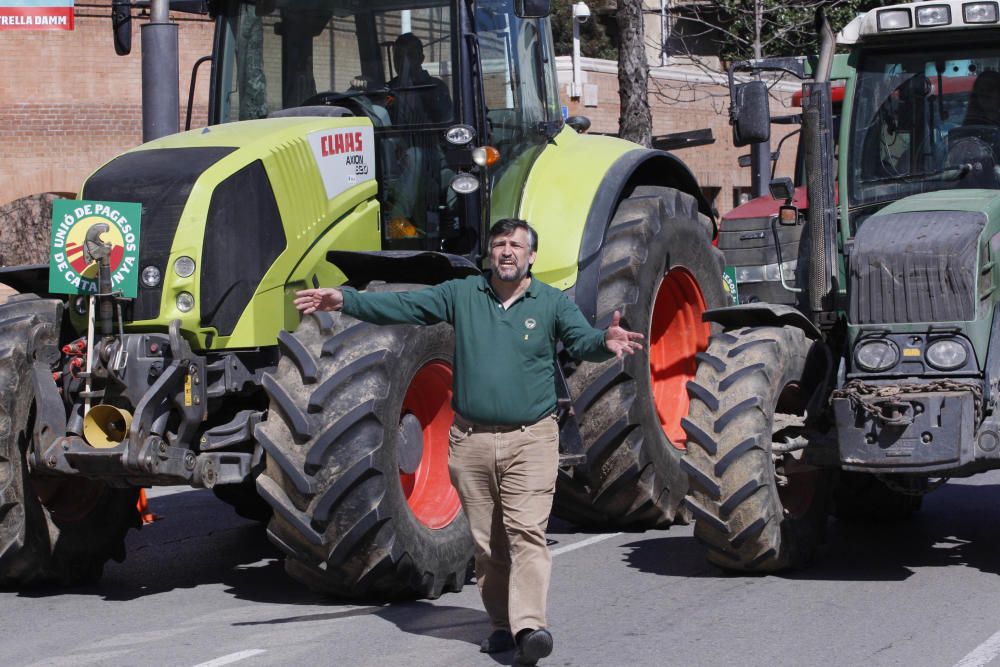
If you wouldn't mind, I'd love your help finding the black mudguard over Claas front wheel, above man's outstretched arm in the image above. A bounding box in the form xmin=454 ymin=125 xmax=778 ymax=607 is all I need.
xmin=326 ymin=250 xmax=480 ymax=285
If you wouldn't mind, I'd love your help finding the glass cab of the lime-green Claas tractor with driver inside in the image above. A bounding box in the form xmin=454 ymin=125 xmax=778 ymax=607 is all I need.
xmin=210 ymin=0 xmax=562 ymax=256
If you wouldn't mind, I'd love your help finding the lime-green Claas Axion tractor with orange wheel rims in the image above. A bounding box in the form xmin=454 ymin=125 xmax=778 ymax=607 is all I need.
xmin=0 ymin=0 xmax=725 ymax=599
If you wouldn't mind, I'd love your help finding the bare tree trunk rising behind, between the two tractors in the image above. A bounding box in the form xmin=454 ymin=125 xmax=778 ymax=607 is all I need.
xmin=615 ymin=0 xmax=653 ymax=148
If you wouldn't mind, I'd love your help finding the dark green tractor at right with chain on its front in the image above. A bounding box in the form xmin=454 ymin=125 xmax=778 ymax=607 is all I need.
xmin=682 ymin=0 xmax=1000 ymax=571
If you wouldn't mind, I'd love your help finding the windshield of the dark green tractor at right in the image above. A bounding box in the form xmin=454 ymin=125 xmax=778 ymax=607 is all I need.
xmin=848 ymin=46 xmax=1000 ymax=207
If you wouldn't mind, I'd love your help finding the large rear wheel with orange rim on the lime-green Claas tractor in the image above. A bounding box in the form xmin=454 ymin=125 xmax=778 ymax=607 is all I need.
xmin=554 ymin=186 xmax=726 ymax=529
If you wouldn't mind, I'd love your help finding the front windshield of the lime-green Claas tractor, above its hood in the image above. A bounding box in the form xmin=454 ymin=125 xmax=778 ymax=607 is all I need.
xmin=219 ymin=0 xmax=455 ymax=127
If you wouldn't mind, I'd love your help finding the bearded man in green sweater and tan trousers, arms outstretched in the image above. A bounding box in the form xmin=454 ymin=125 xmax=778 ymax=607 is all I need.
xmin=295 ymin=219 xmax=642 ymax=665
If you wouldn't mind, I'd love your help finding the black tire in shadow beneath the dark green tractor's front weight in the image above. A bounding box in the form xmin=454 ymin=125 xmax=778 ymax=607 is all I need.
xmin=832 ymin=470 xmax=927 ymax=523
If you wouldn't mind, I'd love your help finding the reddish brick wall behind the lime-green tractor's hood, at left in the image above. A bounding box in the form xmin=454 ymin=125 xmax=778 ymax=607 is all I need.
xmin=0 ymin=0 xmax=213 ymax=206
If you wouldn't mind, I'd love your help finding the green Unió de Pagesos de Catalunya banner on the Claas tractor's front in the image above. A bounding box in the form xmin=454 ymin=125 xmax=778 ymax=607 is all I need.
xmin=49 ymin=199 xmax=142 ymax=299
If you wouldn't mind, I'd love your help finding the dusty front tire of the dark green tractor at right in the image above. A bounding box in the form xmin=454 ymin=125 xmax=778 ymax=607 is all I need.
xmin=681 ymin=327 xmax=833 ymax=572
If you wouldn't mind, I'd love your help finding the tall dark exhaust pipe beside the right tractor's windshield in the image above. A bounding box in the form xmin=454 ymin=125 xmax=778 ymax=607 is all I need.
xmin=802 ymin=9 xmax=838 ymax=324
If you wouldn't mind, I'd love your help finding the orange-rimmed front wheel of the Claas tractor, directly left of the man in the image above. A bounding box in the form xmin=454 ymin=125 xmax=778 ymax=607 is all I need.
xmin=257 ymin=294 xmax=473 ymax=600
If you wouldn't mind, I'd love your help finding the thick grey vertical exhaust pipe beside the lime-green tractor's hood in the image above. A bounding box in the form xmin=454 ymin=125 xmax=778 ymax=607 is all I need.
xmin=140 ymin=0 xmax=181 ymax=142
